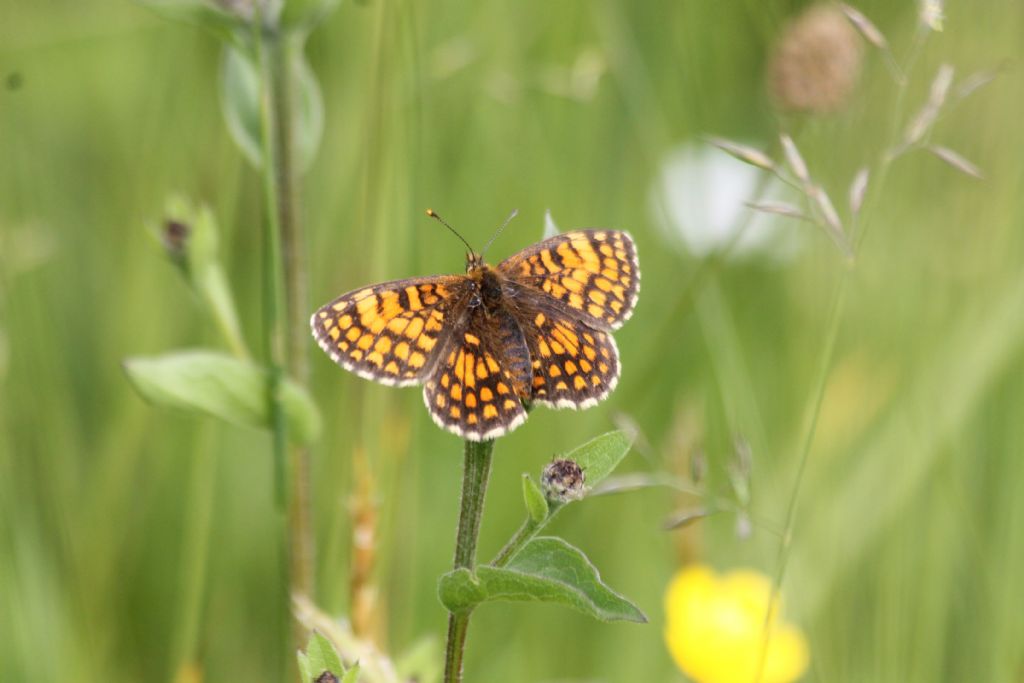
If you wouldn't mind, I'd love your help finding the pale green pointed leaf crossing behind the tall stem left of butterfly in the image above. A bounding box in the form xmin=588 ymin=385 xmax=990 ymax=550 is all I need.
xmin=124 ymin=349 xmax=321 ymax=443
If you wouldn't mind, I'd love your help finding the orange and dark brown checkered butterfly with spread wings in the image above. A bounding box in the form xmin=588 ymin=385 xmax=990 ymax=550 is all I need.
xmin=310 ymin=210 xmax=640 ymax=441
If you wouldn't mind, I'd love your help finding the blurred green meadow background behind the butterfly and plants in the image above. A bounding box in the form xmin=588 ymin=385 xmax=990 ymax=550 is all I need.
xmin=0 ymin=0 xmax=1024 ymax=683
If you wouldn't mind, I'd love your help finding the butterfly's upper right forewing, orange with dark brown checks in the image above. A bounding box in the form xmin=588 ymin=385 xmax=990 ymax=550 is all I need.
xmin=498 ymin=230 xmax=640 ymax=330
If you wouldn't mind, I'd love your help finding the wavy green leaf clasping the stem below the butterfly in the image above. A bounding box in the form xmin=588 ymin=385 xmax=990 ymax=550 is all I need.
xmin=438 ymin=537 xmax=647 ymax=623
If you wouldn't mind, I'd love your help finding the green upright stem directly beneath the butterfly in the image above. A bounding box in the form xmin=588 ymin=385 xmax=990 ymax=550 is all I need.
xmin=444 ymin=440 xmax=495 ymax=683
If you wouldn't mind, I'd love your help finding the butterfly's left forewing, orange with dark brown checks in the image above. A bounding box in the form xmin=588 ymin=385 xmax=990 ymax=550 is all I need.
xmin=310 ymin=275 xmax=465 ymax=386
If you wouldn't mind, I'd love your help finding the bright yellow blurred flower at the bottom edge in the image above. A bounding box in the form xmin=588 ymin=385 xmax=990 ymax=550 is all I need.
xmin=665 ymin=565 xmax=809 ymax=683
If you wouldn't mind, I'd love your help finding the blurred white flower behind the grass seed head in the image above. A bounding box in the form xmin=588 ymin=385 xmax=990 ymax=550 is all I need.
xmin=650 ymin=143 xmax=800 ymax=261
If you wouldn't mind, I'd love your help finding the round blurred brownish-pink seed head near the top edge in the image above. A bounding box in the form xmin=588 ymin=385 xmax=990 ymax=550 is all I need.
xmin=768 ymin=4 xmax=862 ymax=114
